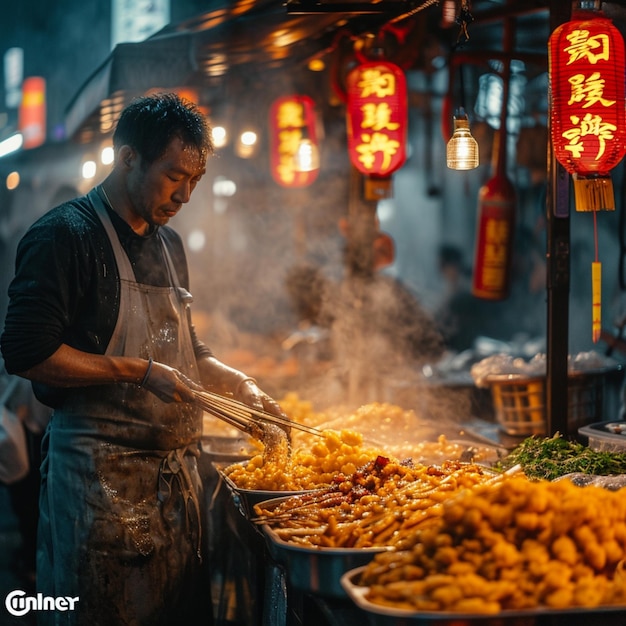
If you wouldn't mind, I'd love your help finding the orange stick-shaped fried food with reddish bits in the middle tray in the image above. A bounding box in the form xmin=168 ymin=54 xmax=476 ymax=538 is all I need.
xmin=255 ymin=457 xmax=493 ymax=544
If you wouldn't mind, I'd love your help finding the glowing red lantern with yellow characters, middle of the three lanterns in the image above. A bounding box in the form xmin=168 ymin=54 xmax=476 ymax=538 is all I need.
xmin=346 ymin=61 xmax=408 ymax=178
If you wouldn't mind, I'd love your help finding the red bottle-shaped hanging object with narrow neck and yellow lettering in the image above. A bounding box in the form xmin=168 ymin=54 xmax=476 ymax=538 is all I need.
xmin=472 ymin=53 xmax=516 ymax=300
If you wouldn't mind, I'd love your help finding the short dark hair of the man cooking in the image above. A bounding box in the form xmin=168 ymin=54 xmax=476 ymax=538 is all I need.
xmin=113 ymin=93 xmax=214 ymax=165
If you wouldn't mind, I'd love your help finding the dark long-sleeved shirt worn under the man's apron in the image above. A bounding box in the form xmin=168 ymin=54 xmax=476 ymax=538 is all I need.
xmin=0 ymin=191 xmax=211 ymax=404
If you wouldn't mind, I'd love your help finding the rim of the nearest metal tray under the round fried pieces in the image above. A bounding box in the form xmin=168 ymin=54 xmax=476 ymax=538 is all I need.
xmin=340 ymin=566 xmax=626 ymax=626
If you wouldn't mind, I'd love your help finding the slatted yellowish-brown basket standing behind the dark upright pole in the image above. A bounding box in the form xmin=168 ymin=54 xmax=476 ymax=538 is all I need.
xmin=486 ymin=372 xmax=605 ymax=436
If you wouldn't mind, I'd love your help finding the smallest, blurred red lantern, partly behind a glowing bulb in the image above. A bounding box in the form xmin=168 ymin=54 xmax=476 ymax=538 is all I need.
xmin=269 ymin=95 xmax=319 ymax=187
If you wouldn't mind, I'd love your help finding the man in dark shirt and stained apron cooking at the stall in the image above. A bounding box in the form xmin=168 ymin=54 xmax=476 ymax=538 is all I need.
xmin=1 ymin=94 xmax=283 ymax=626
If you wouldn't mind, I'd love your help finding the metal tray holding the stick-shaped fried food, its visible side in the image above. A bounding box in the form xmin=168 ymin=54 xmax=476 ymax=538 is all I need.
xmin=261 ymin=524 xmax=386 ymax=599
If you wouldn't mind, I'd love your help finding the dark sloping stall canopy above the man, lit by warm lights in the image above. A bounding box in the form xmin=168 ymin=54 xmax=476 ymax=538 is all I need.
xmin=65 ymin=0 xmax=549 ymax=143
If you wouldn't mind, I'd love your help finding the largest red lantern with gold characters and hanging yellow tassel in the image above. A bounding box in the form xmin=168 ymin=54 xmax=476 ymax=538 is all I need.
xmin=548 ymin=3 xmax=626 ymax=342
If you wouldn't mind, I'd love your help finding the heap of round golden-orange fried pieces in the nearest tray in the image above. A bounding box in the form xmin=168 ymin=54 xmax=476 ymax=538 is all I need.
xmin=360 ymin=476 xmax=626 ymax=614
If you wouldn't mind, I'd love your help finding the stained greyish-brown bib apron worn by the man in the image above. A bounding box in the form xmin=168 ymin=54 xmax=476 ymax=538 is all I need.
xmin=37 ymin=189 xmax=210 ymax=626
